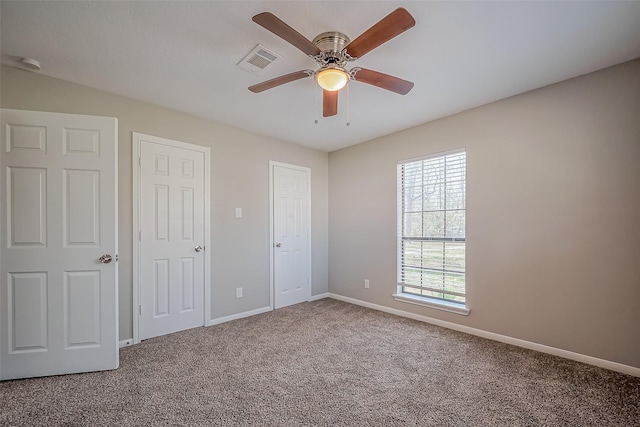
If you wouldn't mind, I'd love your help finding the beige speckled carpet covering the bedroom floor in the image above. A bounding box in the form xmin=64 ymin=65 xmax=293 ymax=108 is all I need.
xmin=0 ymin=299 xmax=640 ymax=426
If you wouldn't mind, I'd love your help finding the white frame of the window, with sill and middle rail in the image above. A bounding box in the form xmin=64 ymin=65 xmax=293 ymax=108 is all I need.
xmin=393 ymin=147 xmax=469 ymax=315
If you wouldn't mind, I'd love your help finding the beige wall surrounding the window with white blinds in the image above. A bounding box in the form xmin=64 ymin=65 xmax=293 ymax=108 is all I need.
xmin=329 ymin=60 xmax=640 ymax=367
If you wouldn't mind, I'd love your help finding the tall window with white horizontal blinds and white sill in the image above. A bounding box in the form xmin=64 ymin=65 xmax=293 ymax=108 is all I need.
xmin=394 ymin=150 xmax=468 ymax=314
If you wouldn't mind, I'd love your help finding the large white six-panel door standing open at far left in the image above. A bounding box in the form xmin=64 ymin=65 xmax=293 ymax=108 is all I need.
xmin=0 ymin=109 xmax=119 ymax=379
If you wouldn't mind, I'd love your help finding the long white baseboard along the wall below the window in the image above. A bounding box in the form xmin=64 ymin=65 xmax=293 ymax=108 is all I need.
xmin=327 ymin=292 xmax=640 ymax=377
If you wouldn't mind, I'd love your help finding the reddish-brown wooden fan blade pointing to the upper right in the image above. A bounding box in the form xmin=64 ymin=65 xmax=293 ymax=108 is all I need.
xmin=346 ymin=7 xmax=416 ymax=58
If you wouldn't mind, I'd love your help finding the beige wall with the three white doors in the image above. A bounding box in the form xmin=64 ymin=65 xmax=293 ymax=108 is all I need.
xmin=0 ymin=66 xmax=328 ymax=340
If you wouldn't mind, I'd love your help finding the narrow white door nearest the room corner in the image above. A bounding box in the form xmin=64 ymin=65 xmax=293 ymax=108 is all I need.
xmin=271 ymin=162 xmax=311 ymax=308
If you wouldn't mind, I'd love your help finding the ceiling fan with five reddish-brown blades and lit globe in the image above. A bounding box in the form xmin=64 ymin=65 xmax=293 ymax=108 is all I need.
xmin=249 ymin=8 xmax=416 ymax=117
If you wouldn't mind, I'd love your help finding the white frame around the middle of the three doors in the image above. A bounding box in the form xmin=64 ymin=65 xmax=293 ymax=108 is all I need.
xmin=131 ymin=132 xmax=212 ymax=344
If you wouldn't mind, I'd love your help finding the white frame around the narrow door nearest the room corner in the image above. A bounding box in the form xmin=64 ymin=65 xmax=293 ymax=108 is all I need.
xmin=269 ymin=160 xmax=313 ymax=310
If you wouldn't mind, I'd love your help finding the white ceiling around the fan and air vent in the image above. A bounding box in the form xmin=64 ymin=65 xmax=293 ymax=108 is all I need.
xmin=0 ymin=0 xmax=640 ymax=151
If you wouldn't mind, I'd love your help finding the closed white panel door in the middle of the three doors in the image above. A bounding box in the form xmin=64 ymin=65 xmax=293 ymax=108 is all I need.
xmin=134 ymin=134 xmax=208 ymax=340
